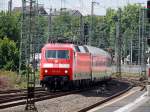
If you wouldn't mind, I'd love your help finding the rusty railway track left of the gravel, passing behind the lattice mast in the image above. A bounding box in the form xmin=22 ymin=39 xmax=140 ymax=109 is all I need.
xmin=0 ymin=85 xmax=101 ymax=109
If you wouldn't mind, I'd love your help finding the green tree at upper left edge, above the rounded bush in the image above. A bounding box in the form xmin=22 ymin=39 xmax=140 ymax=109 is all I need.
xmin=0 ymin=12 xmax=20 ymax=42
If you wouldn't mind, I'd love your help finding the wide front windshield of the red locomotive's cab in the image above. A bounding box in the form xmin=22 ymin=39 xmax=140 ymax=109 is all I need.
xmin=46 ymin=50 xmax=69 ymax=59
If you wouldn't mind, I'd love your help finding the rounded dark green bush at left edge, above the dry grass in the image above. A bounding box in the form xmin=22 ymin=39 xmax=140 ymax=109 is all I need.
xmin=0 ymin=37 xmax=19 ymax=71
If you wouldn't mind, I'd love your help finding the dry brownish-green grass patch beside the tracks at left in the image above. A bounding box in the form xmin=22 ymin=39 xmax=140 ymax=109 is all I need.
xmin=0 ymin=70 xmax=39 ymax=90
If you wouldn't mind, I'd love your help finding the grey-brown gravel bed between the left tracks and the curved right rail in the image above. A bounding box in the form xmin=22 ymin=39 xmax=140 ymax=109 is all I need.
xmin=0 ymin=81 xmax=129 ymax=112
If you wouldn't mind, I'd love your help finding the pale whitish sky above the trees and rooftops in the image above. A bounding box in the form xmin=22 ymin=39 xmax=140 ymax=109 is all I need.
xmin=0 ymin=0 xmax=147 ymax=15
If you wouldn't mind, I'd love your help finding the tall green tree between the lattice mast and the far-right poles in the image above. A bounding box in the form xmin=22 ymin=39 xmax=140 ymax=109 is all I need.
xmin=121 ymin=4 xmax=141 ymax=61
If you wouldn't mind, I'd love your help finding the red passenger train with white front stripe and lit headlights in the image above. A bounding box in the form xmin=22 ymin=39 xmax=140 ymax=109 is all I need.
xmin=40 ymin=43 xmax=112 ymax=89
